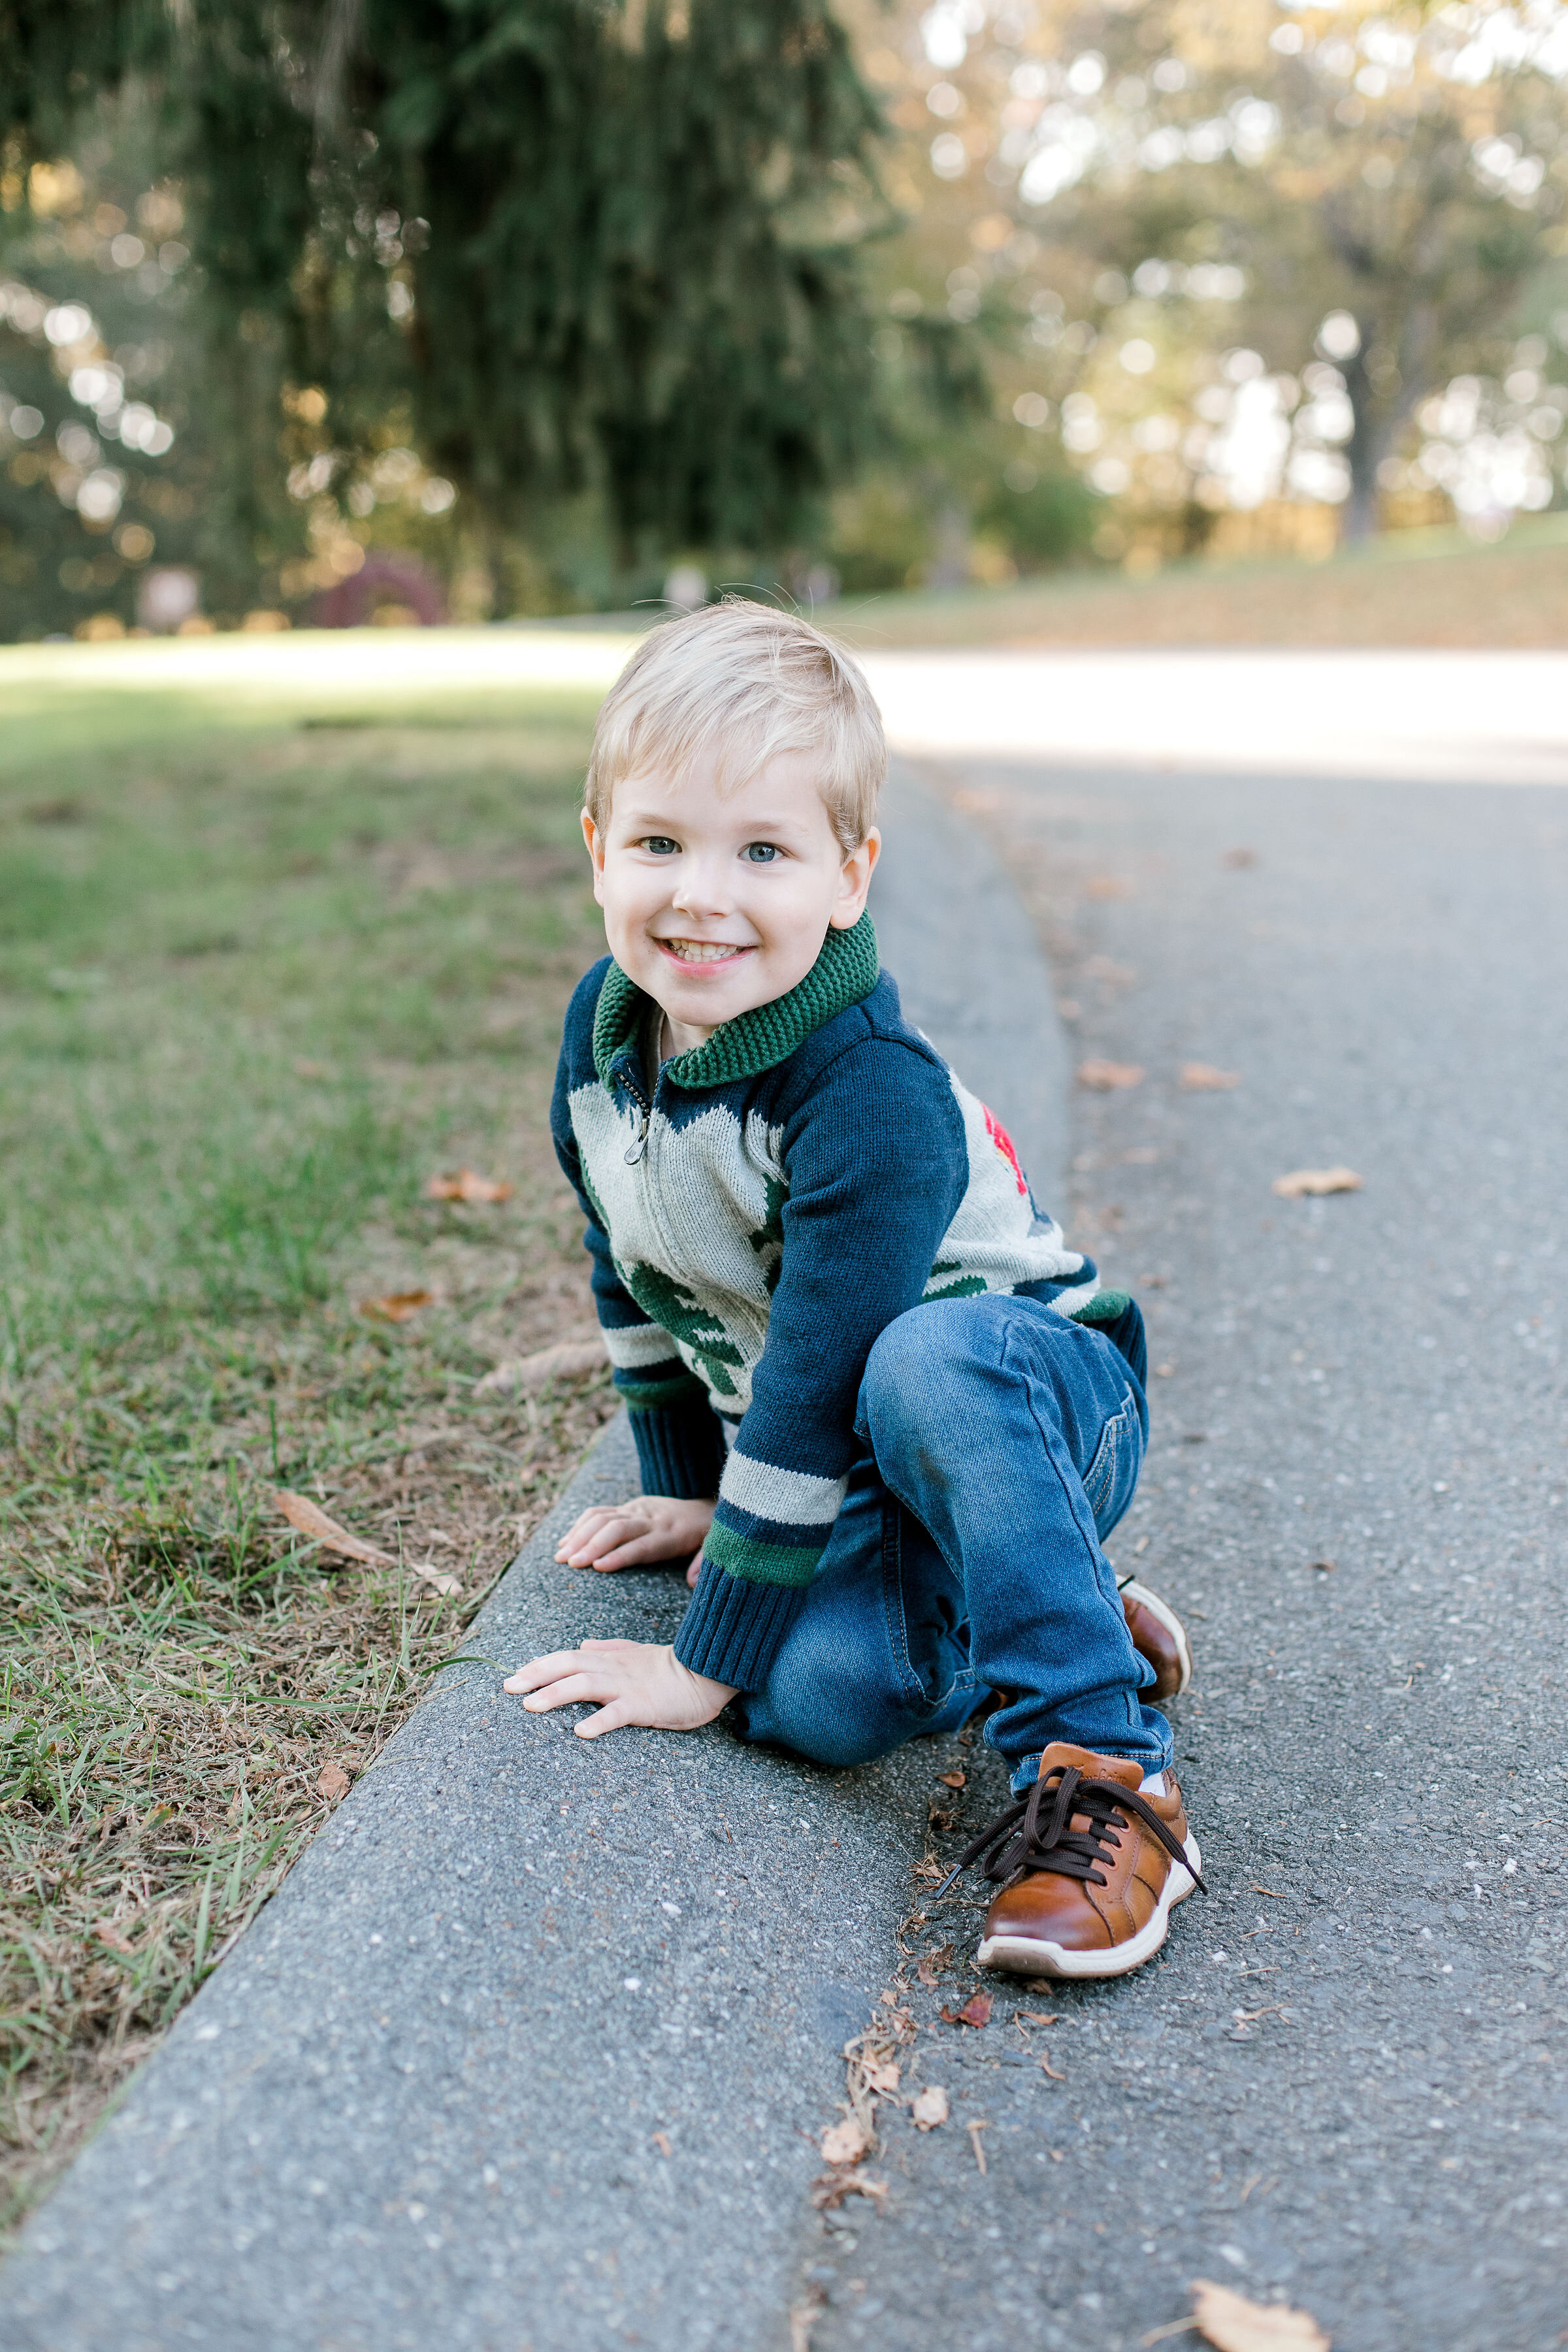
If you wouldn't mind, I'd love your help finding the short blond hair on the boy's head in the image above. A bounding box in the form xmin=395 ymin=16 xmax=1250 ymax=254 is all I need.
xmin=583 ymin=597 xmax=889 ymax=856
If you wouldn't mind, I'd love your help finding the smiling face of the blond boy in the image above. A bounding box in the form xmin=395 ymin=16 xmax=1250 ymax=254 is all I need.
xmin=583 ymin=753 xmax=879 ymax=1049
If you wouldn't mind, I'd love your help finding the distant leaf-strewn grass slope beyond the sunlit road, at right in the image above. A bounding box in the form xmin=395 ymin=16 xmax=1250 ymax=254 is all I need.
xmin=821 ymin=515 xmax=1568 ymax=654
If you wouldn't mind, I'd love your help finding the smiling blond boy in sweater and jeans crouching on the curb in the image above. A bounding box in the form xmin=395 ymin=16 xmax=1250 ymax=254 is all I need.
xmin=506 ymin=602 xmax=1199 ymax=1976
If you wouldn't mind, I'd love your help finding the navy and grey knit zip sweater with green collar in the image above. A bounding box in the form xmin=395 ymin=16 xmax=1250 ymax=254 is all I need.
xmin=553 ymin=915 xmax=1114 ymax=1691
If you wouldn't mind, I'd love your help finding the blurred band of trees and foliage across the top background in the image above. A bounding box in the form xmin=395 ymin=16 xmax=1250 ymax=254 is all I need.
xmin=0 ymin=0 xmax=1568 ymax=638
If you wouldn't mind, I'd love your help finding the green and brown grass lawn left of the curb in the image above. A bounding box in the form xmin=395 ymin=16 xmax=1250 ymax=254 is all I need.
xmin=0 ymin=678 xmax=625 ymax=2220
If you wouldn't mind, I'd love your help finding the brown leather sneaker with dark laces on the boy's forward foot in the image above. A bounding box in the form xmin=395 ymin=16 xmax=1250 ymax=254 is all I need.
xmin=955 ymin=1740 xmax=1203 ymax=1976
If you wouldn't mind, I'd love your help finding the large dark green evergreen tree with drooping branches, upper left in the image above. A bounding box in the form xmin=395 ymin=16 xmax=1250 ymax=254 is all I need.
xmin=0 ymin=0 xmax=887 ymax=578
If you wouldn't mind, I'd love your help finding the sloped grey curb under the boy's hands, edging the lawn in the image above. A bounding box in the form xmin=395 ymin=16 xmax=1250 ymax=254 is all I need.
xmin=0 ymin=776 xmax=1068 ymax=2352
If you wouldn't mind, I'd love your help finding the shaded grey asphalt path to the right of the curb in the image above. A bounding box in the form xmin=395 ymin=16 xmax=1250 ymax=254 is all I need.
xmin=802 ymin=762 xmax=1568 ymax=2352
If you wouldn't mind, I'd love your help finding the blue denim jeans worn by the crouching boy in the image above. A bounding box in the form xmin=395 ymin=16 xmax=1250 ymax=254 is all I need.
xmin=734 ymin=1296 xmax=1171 ymax=1790
